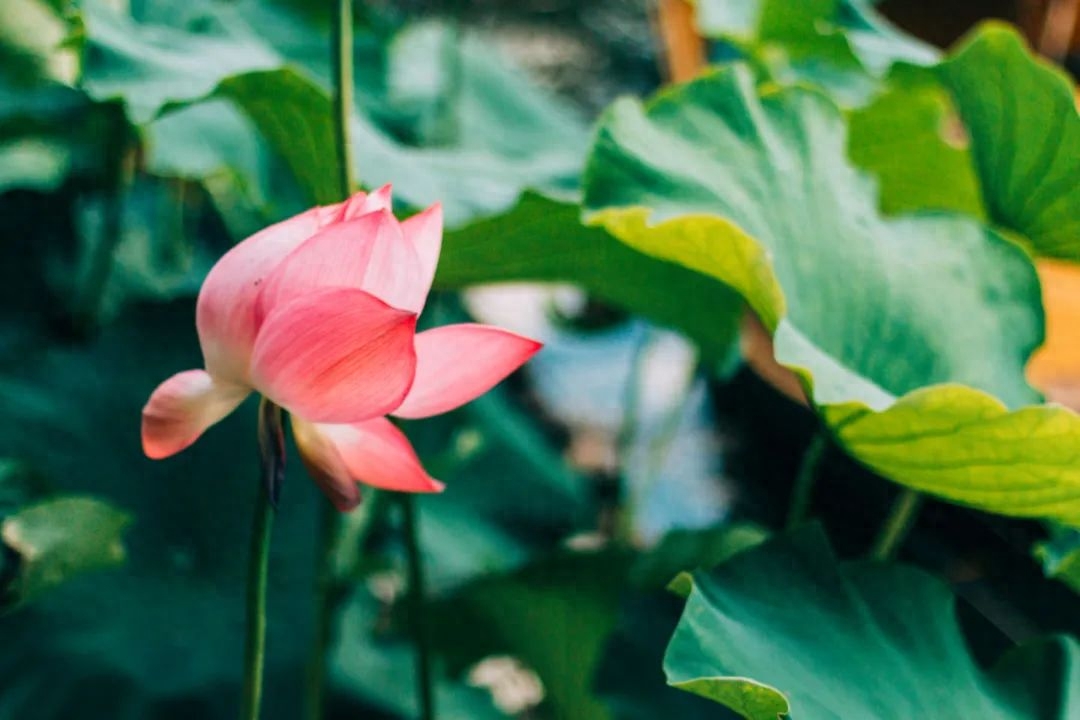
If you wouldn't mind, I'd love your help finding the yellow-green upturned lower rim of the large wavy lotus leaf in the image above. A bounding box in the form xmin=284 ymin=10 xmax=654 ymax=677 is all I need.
xmin=825 ymin=385 xmax=1080 ymax=527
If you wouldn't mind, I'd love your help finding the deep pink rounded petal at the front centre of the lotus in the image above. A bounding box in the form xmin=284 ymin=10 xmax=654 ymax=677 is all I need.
xmin=252 ymin=288 xmax=416 ymax=422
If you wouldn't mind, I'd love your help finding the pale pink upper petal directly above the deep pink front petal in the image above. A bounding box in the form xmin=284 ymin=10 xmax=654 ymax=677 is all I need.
xmin=255 ymin=210 xmax=401 ymax=325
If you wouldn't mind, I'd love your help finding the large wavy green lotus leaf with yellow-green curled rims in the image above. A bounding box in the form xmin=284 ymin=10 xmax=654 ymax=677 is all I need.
xmin=585 ymin=67 xmax=1080 ymax=522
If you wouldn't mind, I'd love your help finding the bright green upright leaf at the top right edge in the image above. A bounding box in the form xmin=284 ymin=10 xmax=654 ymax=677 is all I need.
xmin=939 ymin=24 xmax=1080 ymax=260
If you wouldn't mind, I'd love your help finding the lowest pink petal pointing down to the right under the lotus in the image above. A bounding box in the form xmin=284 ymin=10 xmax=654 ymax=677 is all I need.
xmin=318 ymin=418 xmax=443 ymax=492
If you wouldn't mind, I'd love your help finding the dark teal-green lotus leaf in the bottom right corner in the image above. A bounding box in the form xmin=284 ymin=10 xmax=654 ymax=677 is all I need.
xmin=664 ymin=526 xmax=1080 ymax=720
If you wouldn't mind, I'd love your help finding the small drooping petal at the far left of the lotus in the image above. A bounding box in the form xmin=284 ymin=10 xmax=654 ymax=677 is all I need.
xmin=143 ymin=370 xmax=251 ymax=460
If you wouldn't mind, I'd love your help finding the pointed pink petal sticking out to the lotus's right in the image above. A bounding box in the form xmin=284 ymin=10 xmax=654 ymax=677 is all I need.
xmin=394 ymin=324 xmax=542 ymax=418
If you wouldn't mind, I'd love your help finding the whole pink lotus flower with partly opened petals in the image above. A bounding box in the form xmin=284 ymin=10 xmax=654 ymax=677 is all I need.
xmin=143 ymin=186 xmax=540 ymax=511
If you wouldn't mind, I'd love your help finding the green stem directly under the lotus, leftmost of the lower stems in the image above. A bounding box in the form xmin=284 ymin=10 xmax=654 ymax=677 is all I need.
xmin=240 ymin=397 xmax=285 ymax=720
